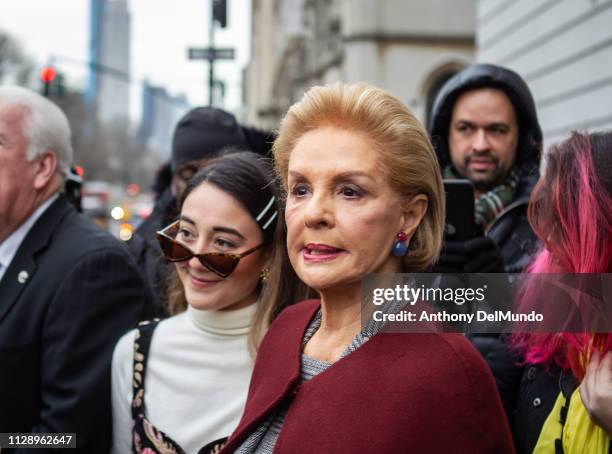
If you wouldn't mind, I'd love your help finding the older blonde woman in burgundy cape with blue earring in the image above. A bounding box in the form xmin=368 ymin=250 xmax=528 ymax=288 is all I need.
xmin=224 ymin=84 xmax=512 ymax=453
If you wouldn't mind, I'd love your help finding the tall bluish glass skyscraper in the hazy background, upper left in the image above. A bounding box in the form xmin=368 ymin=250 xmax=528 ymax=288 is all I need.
xmin=86 ymin=0 xmax=131 ymax=125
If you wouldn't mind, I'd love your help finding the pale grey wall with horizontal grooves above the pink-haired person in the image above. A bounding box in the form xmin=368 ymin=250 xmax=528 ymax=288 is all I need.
xmin=477 ymin=0 xmax=612 ymax=146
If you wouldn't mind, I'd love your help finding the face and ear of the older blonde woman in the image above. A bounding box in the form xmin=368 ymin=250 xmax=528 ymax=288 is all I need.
xmin=285 ymin=127 xmax=427 ymax=290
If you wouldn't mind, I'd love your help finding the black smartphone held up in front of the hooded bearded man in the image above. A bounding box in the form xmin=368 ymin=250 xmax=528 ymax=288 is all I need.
xmin=444 ymin=180 xmax=476 ymax=241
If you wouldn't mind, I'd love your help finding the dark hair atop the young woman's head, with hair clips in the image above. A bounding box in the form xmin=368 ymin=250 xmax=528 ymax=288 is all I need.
xmin=179 ymin=151 xmax=279 ymax=243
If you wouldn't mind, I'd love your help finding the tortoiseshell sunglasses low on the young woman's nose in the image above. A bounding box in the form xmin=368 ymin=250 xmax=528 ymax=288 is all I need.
xmin=156 ymin=221 xmax=265 ymax=278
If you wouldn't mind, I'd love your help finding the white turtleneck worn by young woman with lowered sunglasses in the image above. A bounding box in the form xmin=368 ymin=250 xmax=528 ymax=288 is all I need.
xmin=112 ymin=304 xmax=256 ymax=454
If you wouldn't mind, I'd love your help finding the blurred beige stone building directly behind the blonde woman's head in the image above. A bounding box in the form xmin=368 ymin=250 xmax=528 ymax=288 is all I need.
xmin=244 ymin=0 xmax=476 ymax=128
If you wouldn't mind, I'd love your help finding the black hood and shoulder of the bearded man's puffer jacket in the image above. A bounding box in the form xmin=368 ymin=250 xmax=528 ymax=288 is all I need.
xmin=429 ymin=64 xmax=542 ymax=272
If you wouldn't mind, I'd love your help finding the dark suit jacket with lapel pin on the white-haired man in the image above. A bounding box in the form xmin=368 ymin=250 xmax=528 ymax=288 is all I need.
xmin=0 ymin=196 xmax=147 ymax=454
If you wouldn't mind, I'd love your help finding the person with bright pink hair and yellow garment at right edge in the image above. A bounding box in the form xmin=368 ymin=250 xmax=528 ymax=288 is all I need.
xmin=502 ymin=132 xmax=612 ymax=453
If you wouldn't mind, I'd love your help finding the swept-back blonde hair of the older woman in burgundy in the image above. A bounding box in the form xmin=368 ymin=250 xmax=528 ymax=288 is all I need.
xmin=272 ymin=83 xmax=444 ymax=272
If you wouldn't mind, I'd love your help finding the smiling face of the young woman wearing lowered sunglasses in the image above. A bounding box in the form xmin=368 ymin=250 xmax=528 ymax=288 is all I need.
xmin=176 ymin=183 xmax=265 ymax=310
